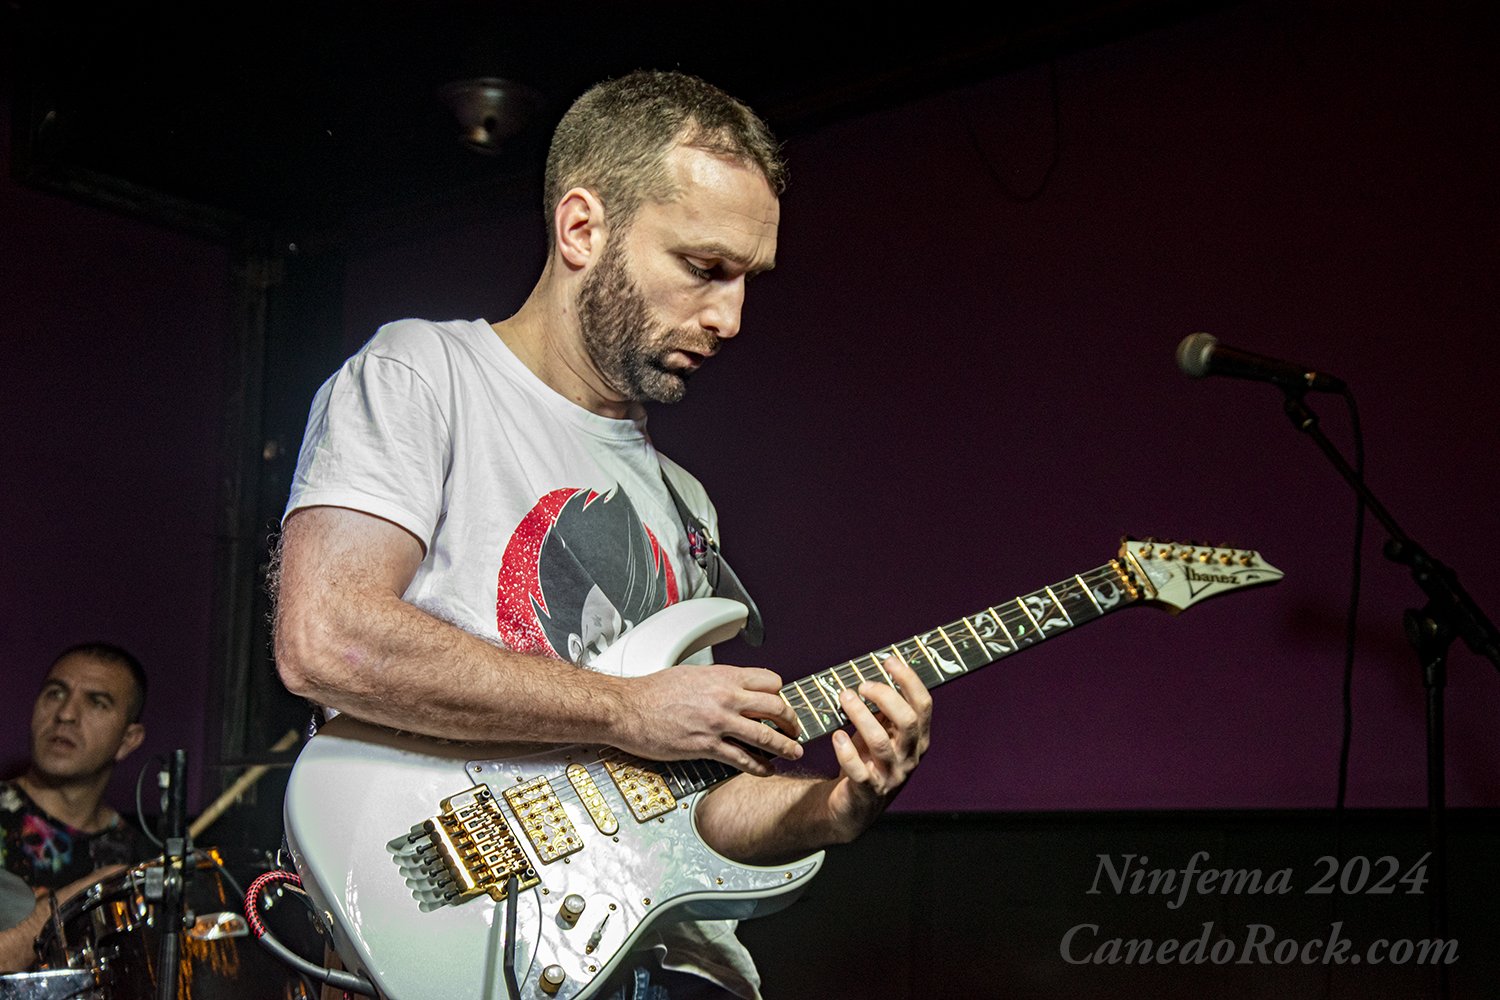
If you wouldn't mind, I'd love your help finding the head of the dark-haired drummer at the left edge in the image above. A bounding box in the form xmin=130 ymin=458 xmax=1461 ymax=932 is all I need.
xmin=32 ymin=642 xmax=146 ymax=781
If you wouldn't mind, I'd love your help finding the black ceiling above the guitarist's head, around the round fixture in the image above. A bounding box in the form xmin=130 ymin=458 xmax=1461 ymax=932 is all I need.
xmin=0 ymin=0 xmax=1224 ymax=239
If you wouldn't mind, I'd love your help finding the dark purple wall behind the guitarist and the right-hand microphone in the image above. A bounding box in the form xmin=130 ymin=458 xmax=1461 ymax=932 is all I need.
xmin=347 ymin=3 xmax=1500 ymax=810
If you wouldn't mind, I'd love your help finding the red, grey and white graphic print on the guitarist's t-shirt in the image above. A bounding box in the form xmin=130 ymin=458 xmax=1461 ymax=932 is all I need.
xmin=495 ymin=486 xmax=677 ymax=666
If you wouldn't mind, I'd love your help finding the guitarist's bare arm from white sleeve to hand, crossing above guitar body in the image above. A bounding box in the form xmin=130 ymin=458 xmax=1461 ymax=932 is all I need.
xmin=276 ymin=507 xmax=801 ymax=775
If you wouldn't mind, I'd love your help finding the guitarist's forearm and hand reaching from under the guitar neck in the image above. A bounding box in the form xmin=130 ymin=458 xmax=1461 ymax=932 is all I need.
xmin=698 ymin=658 xmax=932 ymax=864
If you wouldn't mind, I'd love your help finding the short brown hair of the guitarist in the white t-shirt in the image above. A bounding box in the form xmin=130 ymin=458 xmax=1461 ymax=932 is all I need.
xmin=543 ymin=70 xmax=786 ymax=247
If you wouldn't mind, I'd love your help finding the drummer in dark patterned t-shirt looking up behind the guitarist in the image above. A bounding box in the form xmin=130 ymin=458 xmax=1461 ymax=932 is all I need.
xmin=0 ymin=642 xmax=153 ymax=972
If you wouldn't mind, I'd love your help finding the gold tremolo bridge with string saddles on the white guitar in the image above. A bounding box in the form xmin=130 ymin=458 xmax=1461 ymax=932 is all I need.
xmin=413 ymin=784 xmax=542 ymax=904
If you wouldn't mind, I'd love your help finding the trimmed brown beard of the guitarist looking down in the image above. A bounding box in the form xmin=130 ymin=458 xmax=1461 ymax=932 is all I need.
xmin=578 ymin=235 xmax=713 ymax=403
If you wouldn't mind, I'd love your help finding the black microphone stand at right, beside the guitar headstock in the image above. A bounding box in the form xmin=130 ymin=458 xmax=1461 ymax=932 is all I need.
xmin=1277 ymin=381 xmax=1500 ymax=997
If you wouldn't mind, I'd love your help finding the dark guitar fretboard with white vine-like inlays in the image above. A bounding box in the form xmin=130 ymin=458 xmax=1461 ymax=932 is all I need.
xmin=654 ymin=562 xmax=1139 ymax=796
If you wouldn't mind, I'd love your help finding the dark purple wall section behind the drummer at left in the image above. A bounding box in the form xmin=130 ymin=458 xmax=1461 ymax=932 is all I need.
xmin=0 ymin=103 xmax=230 ymax=811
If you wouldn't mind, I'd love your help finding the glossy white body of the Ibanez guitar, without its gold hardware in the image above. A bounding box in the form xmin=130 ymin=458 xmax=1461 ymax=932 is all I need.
xmin=285 ymin=598 xmax=824 ymax=1000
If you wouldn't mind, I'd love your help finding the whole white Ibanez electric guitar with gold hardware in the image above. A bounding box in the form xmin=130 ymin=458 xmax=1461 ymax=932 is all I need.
xmin=285 ymin=538 xmax=1283 ymax=1000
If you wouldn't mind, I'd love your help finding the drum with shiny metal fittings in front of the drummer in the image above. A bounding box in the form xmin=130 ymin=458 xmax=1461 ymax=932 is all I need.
xmin=36 ymin=850 xmax=314 ymax=1000
